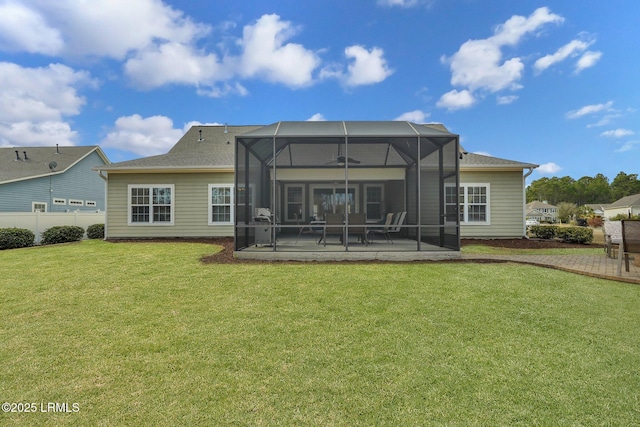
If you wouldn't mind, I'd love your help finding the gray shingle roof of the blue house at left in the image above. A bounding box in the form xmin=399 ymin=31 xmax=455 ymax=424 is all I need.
xmin=0 ymin=145 xmax=109 ymax=184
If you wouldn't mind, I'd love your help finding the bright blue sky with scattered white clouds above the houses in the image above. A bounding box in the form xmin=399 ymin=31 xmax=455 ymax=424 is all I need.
xmin=0 ymin=0 xmax=640 ymax=180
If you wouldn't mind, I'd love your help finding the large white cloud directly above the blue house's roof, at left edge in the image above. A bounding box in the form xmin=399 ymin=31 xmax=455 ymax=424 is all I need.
xmin=0 ymin=62 xmax=95 ymax=146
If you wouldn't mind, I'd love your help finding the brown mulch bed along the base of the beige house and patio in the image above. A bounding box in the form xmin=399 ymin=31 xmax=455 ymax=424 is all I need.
xmin=114 ymin=237 xmax=590 ymax=264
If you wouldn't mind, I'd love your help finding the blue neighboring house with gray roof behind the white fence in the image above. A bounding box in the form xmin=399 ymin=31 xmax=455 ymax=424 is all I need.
xmin=0 ymin=145 xmax=110 ymax=212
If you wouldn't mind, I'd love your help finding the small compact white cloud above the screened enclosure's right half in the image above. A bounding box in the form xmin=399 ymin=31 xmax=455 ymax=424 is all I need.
xmin=344 ymin=45 xmax=393 ymax=86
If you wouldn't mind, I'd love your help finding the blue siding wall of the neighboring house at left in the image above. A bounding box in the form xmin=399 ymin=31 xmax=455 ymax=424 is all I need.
xmin=0 ymin=151 xmax=105 ymax=212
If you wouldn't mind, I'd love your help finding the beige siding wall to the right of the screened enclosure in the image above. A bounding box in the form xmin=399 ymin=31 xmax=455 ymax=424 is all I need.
xmin=460 ymin=171 xmax=525 ymax=238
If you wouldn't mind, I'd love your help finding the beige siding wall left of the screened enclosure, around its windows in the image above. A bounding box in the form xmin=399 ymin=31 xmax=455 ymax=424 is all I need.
xmin=106 ymin=173 xmax=233 ymax=239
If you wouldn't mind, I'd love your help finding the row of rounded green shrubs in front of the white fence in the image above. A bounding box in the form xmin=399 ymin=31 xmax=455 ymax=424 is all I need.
xmin=0 ymin=224 xmax=104 ymax=250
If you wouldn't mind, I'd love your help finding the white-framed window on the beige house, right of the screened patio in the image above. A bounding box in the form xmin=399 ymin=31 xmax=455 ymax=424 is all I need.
xmin=445 ymin=184 xmax=490 ymax=225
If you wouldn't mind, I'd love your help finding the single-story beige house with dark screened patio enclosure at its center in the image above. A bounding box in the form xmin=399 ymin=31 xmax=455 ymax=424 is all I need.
xmin=95 ymin=122 xmax=537 ymax=260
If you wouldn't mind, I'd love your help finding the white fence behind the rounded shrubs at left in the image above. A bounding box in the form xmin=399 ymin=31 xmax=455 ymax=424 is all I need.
xmin=0 ymin=211 xmax=105 ymax=243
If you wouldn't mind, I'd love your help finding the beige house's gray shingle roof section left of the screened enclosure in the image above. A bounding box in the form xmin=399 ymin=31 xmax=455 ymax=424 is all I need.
xmin=94 ymin=125 xmax=262 ymax=172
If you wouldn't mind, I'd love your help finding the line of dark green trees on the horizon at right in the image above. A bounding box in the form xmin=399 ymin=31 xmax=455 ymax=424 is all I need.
xmin=527 ymin=172 xmax=640 ymax=206
